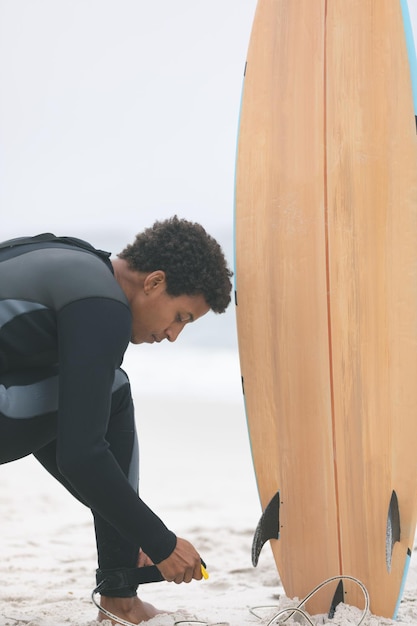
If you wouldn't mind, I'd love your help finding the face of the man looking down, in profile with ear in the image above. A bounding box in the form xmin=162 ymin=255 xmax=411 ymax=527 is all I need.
xmin=130 ymin=272 xmax=210 ymax=344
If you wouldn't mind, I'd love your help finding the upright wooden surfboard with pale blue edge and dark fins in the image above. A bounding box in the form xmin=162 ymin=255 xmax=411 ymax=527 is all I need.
xmin=235 ymin=0 xmax=417 ymax=618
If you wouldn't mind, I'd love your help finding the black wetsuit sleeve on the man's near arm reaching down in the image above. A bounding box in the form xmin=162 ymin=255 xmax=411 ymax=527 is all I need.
xmin=57 ymin=298 xmax=176 ymax=563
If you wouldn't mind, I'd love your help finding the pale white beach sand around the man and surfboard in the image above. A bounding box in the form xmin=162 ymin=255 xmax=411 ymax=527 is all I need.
xmin=0 ymin=394 xmax=417 ymax=626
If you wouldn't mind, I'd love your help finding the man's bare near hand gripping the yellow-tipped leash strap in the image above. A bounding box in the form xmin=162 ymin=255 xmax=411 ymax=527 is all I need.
xmin=157 ymin=537 xmax=203 ymax=584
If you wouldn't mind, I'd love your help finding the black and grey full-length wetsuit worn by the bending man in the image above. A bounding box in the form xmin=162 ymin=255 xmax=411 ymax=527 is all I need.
xmin=0 ymin=235 xmax=176 ymax=595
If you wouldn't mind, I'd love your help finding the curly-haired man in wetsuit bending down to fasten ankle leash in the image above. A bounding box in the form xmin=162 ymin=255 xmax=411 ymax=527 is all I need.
xmin=0 ymin=217 xmax=232 ymax=624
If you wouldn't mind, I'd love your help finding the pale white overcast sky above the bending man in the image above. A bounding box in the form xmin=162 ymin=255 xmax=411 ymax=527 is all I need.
xmin=0 ymin=0 xmax=256 ymax=251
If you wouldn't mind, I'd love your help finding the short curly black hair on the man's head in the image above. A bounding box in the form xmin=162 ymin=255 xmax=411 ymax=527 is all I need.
xmin=118 ymin=215 xmax=233 ymax=313
